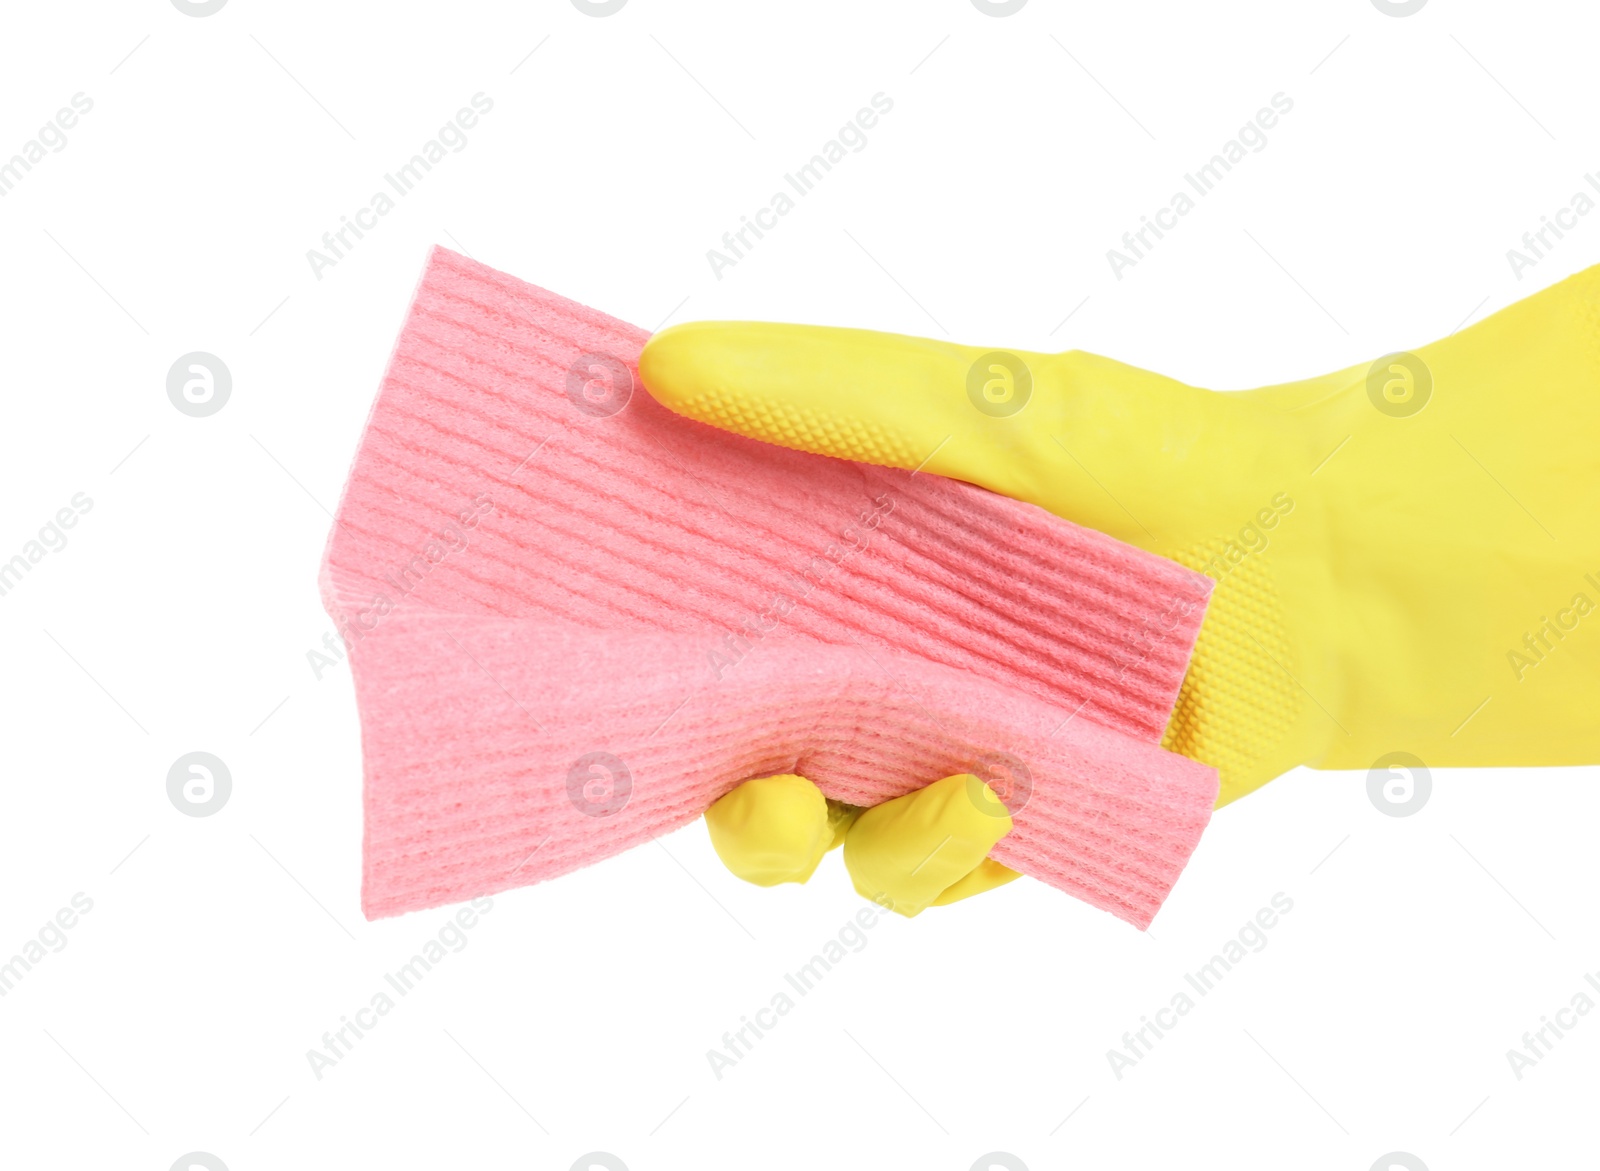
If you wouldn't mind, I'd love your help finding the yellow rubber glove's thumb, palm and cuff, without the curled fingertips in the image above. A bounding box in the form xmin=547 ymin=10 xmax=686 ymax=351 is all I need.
xmin=640 ymin=267 xmax=1600 ymax=803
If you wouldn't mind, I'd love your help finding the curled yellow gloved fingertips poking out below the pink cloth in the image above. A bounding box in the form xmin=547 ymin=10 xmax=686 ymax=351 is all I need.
xmin=706 ymin=774 xmax=1018 ymax=918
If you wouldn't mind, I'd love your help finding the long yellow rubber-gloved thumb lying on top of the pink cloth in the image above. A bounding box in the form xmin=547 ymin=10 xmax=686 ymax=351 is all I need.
xmin=638 ymin=322 xmax=1230 ymax=549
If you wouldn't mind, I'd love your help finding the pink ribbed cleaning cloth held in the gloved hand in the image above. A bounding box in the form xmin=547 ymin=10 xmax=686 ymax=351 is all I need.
xmin=322 ymin=248 xmax=1218 ymax=928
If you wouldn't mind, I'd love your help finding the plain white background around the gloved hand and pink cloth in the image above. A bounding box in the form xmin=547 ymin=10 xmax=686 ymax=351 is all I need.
xmin=0 ymin=0 xmax=1600 ymax=1171
